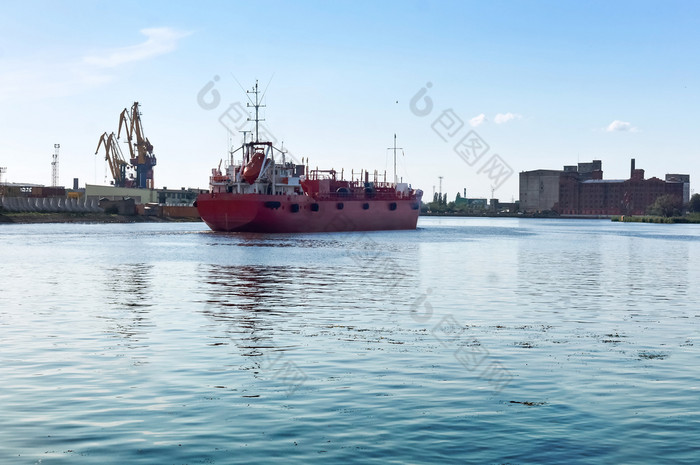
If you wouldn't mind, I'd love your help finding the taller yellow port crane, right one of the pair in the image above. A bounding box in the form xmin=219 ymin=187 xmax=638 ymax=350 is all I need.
xmin=117 ymin=102 xmax=156 ymax=189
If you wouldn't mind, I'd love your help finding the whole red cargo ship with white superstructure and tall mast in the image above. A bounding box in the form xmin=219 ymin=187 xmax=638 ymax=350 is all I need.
xmin=195 ymin=83 xmax=423 ymax=233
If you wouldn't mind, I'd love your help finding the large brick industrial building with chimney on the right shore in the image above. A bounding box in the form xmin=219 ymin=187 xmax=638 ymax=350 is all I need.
xmin=520 ymin=159 xmax=690 ymax=216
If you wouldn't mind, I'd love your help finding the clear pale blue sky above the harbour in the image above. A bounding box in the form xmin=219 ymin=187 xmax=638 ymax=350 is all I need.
xmin=0 ymin=0 xmax=700 ymax=201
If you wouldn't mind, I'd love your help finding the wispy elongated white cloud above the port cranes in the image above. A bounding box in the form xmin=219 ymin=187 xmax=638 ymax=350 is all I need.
xmin=83 ymin=27 xmax=190 ymax=68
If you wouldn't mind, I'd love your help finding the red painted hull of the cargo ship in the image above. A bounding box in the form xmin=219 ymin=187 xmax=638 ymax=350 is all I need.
xmin=197 ymin=193 xmax=420 ymax=233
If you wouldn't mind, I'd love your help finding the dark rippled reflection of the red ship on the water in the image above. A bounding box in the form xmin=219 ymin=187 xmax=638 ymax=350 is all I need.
xmin=199 ymin=262 xmax=420 ymax=357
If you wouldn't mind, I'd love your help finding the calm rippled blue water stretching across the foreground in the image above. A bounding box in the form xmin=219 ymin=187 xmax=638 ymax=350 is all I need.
xmin=0 ymin=218 xmax=700 ymax=464
